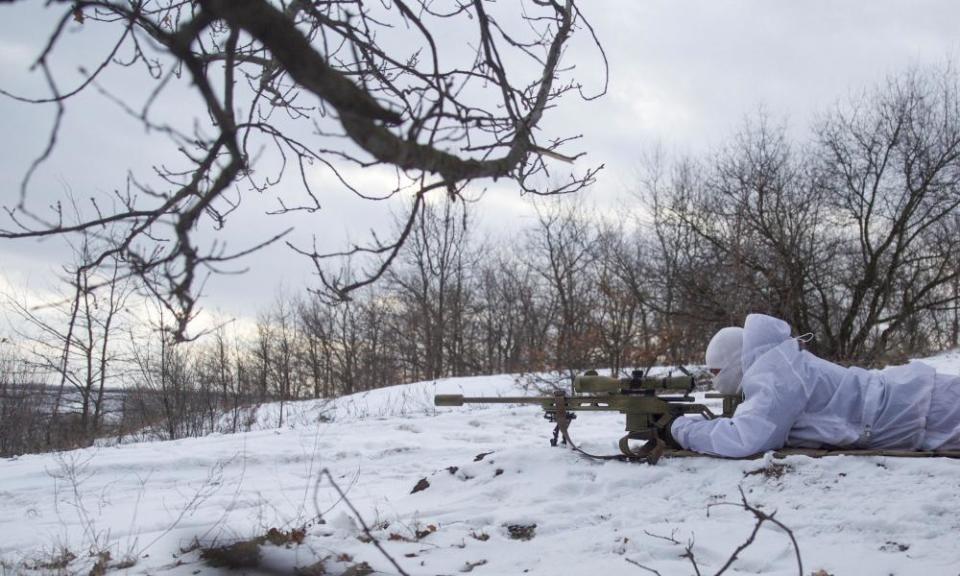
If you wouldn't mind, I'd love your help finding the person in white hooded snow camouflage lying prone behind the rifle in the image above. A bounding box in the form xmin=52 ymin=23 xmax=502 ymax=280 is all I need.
xmin=666 ymin=314 xmax=960 ymax=458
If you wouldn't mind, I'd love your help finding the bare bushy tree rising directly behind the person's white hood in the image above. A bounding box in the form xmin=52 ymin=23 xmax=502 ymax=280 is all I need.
xmin=647 ymin=115 xmax=826 ymax=342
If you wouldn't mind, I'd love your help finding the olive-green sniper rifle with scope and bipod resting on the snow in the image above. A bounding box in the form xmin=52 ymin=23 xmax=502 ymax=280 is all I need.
xmin=434 ymin=367 xmax=742 ymax=464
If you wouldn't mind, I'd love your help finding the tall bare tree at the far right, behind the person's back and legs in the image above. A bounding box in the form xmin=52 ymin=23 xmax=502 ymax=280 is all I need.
xmin=814 ymin=65 xmax=960 ymax=357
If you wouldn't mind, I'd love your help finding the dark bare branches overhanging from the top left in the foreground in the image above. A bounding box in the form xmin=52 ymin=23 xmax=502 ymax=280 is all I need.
xmin=0 ymin=0 xmax=605 ymax=338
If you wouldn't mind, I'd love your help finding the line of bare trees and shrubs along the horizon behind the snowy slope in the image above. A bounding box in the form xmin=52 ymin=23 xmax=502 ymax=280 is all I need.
xmin=0 ymin=66 xmax=960 ymax=454
